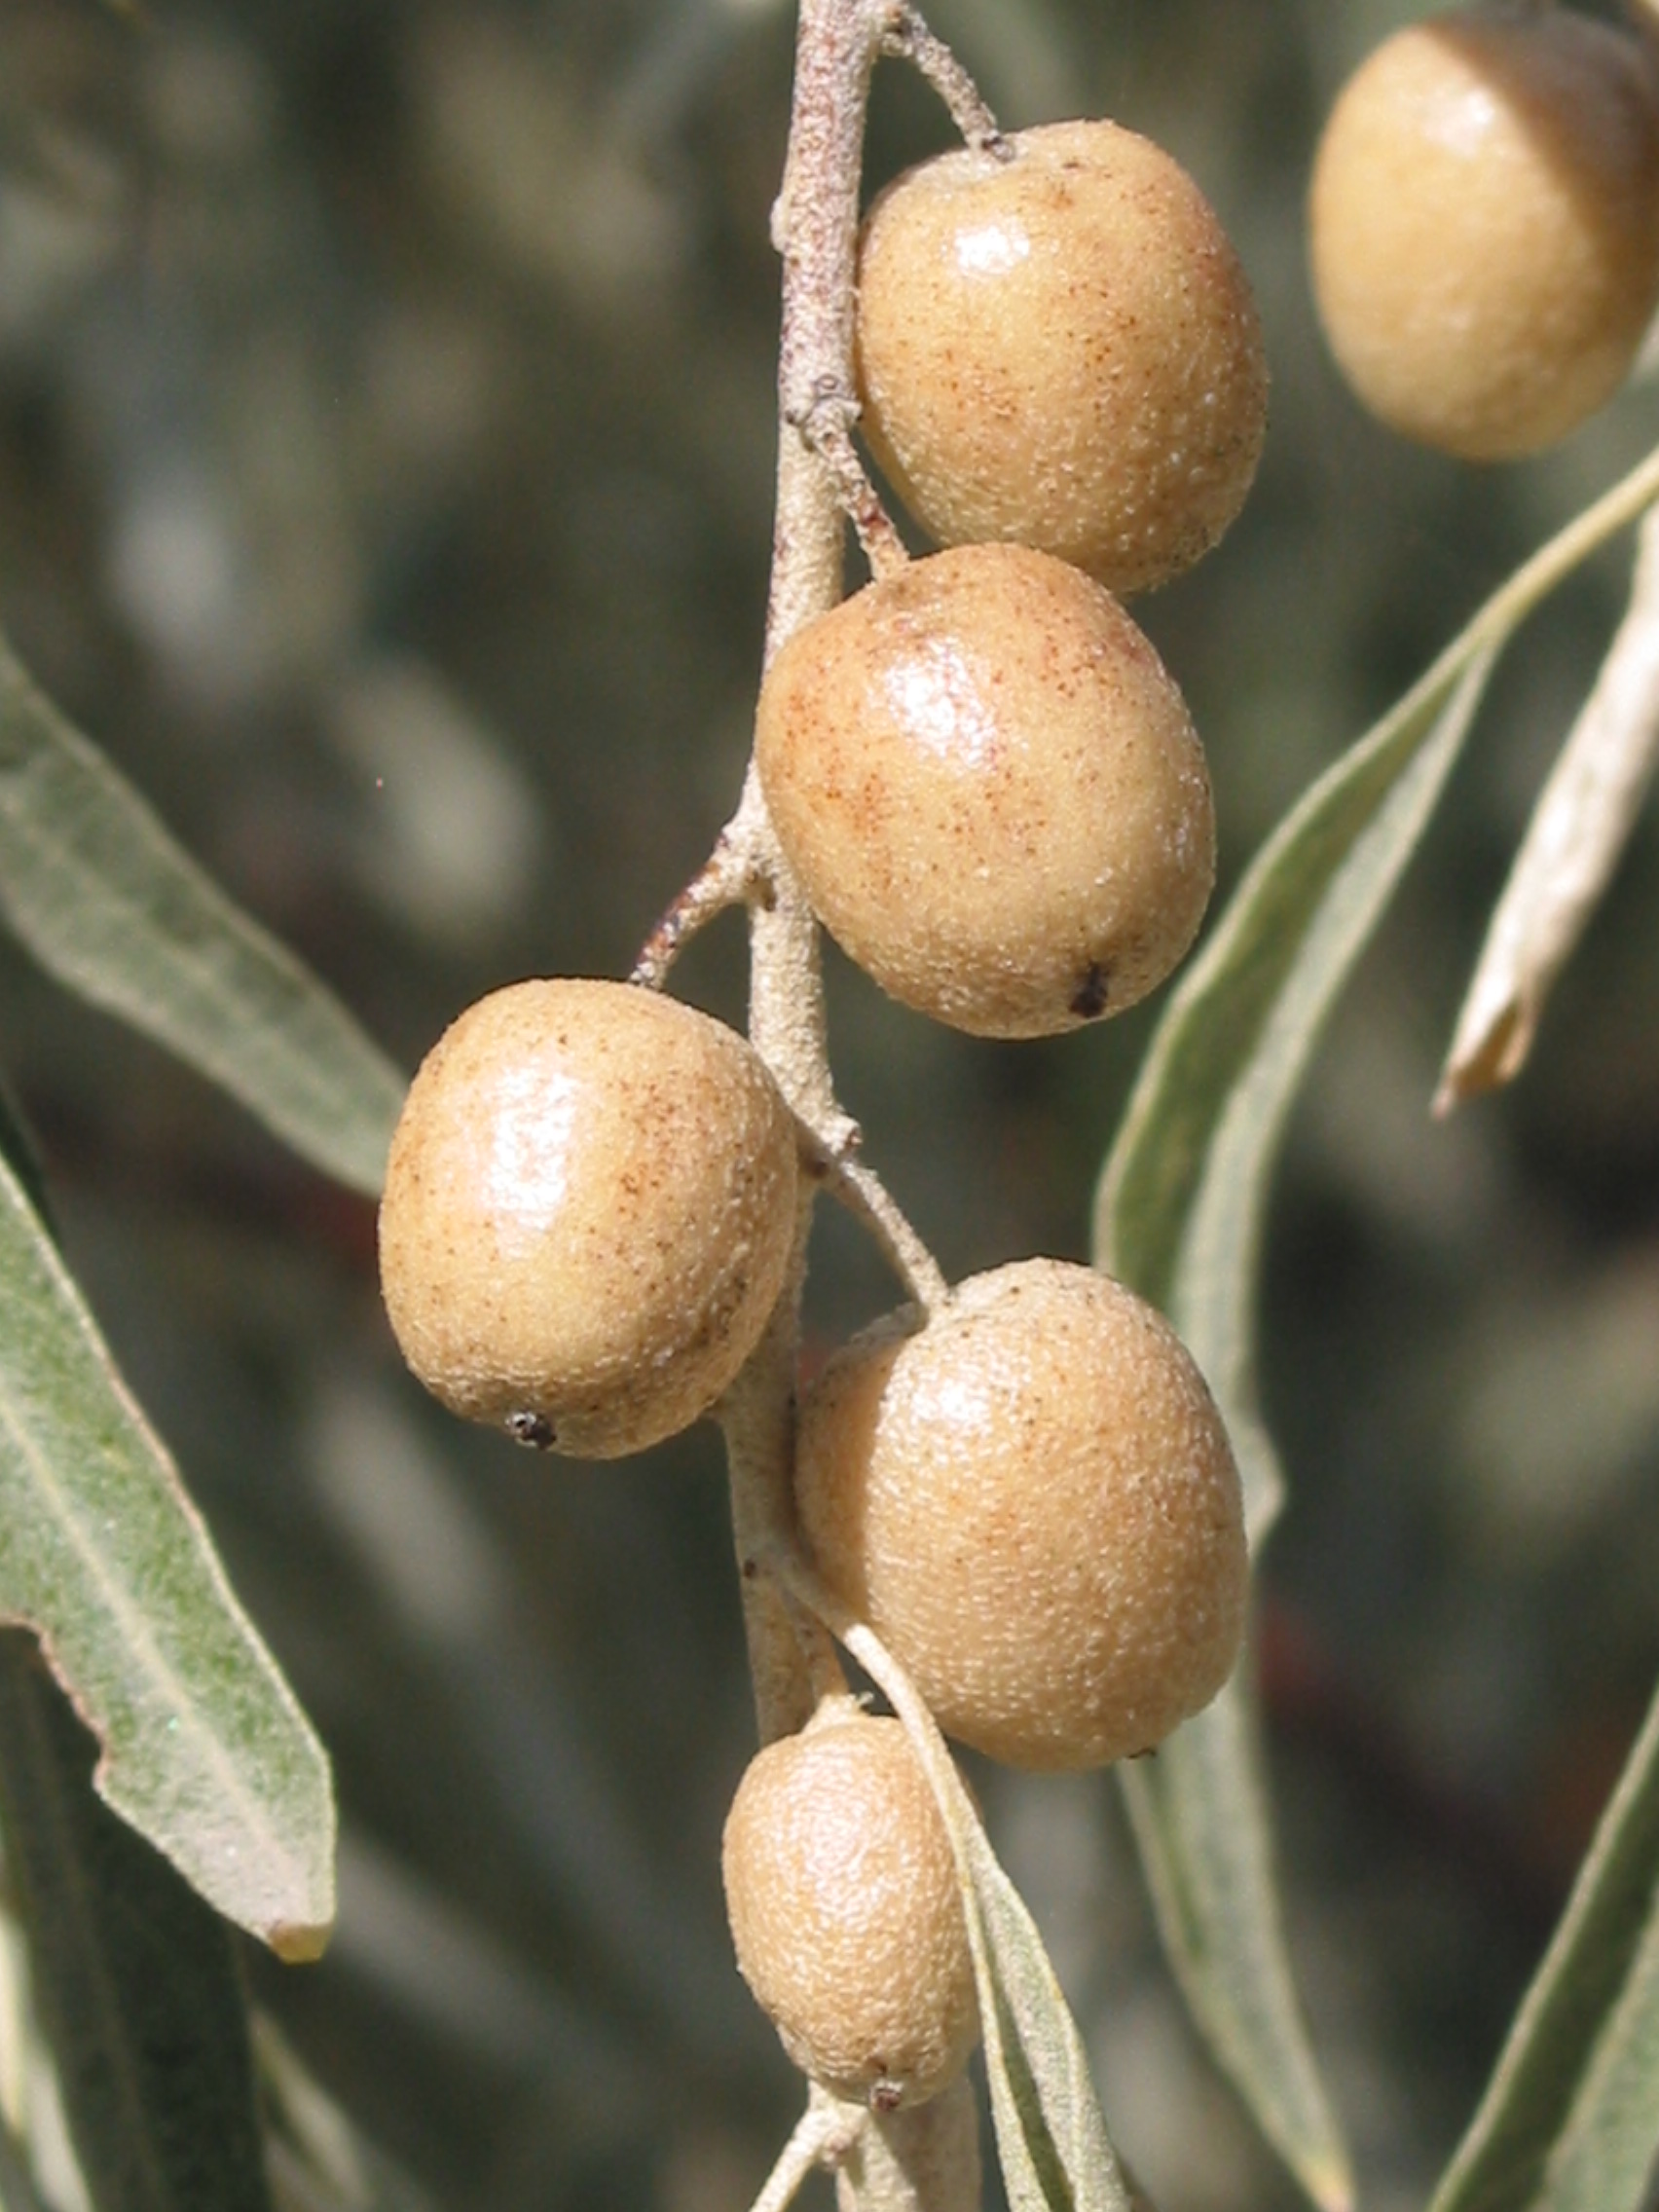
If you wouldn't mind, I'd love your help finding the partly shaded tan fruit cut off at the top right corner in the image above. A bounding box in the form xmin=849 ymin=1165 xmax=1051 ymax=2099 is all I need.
xmin=1309 ymin=7 xmax=1659 ymax=461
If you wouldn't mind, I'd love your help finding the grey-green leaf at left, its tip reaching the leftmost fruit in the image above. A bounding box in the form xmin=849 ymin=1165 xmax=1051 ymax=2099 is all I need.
xmin=0 ymin=637 xmax=405 ymax=1195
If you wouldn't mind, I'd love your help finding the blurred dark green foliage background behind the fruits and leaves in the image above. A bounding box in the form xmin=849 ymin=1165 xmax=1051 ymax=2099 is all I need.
xmin=0 ymin=0 xmax=1659 ymax=2212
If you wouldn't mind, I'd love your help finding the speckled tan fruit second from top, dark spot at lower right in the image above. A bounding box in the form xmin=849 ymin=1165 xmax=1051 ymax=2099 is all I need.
xmin=755 ymin=544 xmax=1214 ymax=1038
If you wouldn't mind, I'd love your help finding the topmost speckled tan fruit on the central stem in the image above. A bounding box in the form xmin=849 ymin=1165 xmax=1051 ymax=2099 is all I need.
xmin=856 ymin=122 xmax=1268 ymax=593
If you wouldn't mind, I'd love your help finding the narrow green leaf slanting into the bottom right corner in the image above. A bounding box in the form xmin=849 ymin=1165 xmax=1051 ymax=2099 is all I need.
xmin=1431 ymin=1697 xmax=1659 ymax=2212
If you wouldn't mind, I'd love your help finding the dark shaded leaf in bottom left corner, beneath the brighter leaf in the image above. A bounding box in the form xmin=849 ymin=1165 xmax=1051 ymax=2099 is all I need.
xmin=0 ymin=1628 xmax=270 ymax=2212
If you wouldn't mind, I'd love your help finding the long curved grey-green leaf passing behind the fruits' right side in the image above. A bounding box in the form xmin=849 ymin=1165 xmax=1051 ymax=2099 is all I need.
xmin=1095 ymin=431 xmax=1659 ymax=2207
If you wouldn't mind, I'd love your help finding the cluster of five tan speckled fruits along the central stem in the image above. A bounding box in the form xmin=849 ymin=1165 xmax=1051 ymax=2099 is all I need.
xmin=381 ymin=107 xmax=1266 ymax=2108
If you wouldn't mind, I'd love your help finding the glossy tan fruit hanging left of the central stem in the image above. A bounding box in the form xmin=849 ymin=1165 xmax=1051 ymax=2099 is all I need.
xmin=381 ymin=977 xmax=796 ymax=1460
